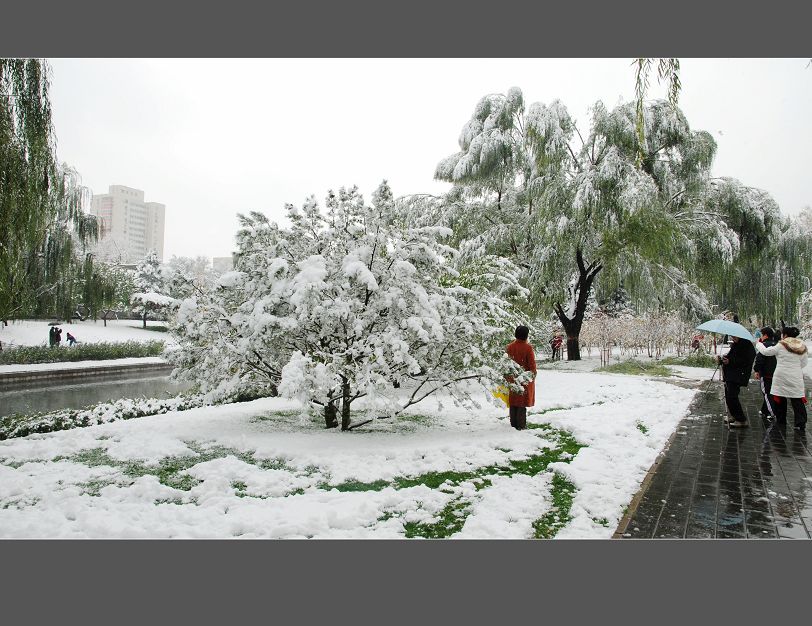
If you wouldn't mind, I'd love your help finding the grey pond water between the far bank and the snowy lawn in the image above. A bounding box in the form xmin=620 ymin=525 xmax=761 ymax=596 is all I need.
xmin=0 ymin=374 xmax=190 ymax=417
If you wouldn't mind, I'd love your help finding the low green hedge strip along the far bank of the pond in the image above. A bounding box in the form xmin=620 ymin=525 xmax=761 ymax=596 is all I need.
xmin=0 ymin=341 xmax=164 ymax=365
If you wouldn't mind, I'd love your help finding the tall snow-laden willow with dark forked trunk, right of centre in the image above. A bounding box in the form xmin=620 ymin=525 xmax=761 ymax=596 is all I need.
xmin=432 ymin=88 xmax=734 ymax=359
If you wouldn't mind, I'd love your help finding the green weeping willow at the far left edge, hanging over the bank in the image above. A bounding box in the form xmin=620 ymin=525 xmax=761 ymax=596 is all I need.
xmin=0 ymin=59 xmax=98 ymax=321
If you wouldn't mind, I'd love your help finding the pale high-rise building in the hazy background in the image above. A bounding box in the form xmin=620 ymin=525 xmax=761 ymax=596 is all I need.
xmin=90 ymin=185 xmax=166 ymax=263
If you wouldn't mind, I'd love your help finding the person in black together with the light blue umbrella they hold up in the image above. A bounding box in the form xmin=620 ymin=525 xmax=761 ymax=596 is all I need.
xmin=697 ymin=320 xmax=756 ymax=428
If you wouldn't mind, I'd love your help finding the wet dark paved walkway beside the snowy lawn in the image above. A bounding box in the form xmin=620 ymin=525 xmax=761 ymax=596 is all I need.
xmin=615 ymin=381 xmax=812 ymax=539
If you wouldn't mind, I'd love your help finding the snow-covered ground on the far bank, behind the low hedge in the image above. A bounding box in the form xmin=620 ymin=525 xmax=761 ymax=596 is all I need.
xmin=0 ymin=320 xmax=175 ymax=349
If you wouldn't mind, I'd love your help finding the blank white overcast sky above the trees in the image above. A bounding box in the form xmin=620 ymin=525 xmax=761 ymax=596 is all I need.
xmin=51 ymin=59 xmax=812 ymax=259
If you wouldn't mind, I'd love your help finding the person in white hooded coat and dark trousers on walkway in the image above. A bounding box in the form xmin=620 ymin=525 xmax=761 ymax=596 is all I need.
xmin=756 ymin=326 xmax=809 ymax=430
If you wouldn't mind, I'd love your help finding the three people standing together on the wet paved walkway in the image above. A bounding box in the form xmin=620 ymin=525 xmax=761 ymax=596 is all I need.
xmin=717 ymin=326 xmax=808 ymax=431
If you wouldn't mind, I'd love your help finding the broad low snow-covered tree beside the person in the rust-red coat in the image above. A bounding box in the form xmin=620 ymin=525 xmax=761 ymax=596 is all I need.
xmin=172 ymin=183 xmax=522 ymax=430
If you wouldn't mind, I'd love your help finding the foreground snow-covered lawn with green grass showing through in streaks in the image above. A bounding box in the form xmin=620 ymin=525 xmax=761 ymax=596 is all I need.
xmin=0 ymin=371 xmax=694 ymax=538
